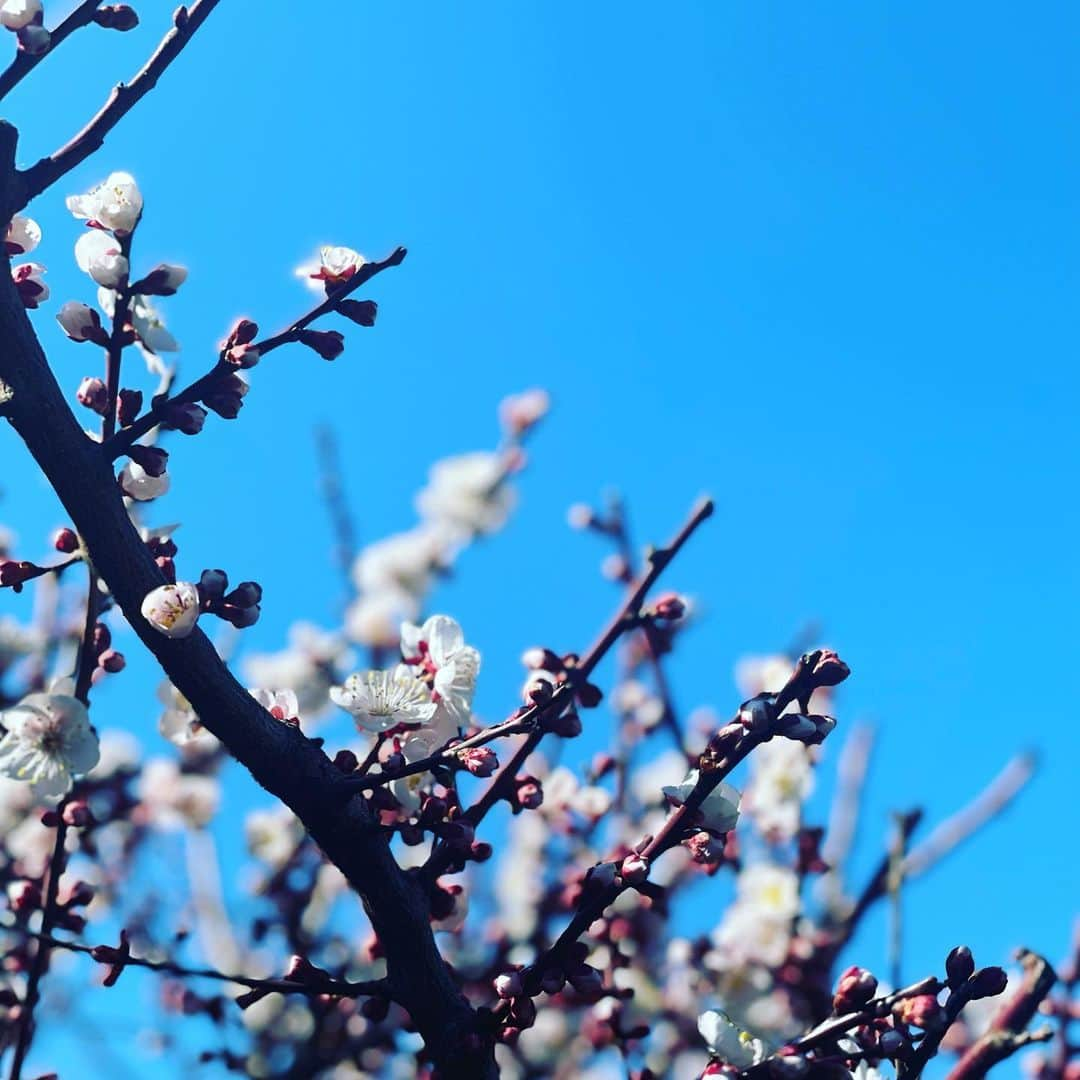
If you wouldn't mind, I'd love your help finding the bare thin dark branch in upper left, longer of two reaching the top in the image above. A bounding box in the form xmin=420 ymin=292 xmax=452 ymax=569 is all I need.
xmin=8 ymin=0 xmax=218 ymax=214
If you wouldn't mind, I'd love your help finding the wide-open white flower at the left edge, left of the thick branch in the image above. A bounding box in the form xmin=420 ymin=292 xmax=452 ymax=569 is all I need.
xmin=0 ymin=693 xmax=98 ymax=798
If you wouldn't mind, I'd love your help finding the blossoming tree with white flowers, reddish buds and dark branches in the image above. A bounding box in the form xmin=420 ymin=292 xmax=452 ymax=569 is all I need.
xmin=0 ymin=0 xmax=1080 ymax=1080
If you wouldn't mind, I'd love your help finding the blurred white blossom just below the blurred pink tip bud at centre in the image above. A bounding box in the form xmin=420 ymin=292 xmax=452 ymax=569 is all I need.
xmin=416 ymin=450 xmax=515 ymax=536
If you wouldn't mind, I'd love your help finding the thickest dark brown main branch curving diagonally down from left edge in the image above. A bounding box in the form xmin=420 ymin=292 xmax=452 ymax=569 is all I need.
xmin=0 ymin=123 xmax=495 ymax=1078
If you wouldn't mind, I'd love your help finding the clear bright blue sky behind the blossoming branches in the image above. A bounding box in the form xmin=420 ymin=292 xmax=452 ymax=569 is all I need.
xmin=0 ymin=0 xmax=1080 ymax=1071
